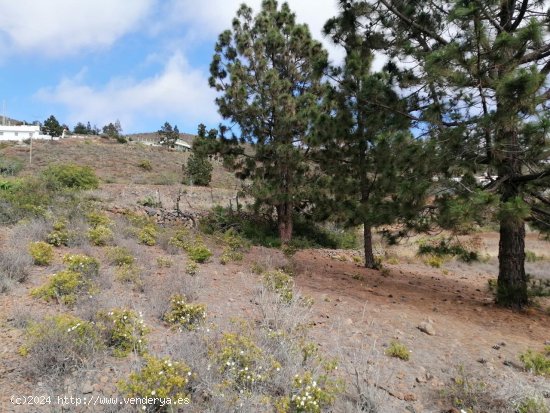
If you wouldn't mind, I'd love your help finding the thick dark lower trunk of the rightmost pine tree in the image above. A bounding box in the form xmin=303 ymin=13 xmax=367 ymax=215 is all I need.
xmin=497 ymin=184 xmax=529 ymax=309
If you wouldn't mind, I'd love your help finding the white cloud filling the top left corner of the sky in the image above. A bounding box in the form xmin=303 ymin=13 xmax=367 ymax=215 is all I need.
xmin=0 ymin=0 xmax=156 ymax=56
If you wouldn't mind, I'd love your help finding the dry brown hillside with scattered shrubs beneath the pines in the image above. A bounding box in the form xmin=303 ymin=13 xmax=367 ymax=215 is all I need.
xmin=0 ymin=138 xmax=550 ymax=413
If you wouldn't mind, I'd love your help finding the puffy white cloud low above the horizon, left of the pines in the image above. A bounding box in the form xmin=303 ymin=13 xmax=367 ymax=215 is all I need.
xmin=35 ymin=52 xmax=218 ymax=132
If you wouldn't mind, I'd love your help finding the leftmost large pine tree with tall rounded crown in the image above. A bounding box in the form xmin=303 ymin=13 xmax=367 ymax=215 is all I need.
xmin=210 ymin=0 xmax=327 ymax=243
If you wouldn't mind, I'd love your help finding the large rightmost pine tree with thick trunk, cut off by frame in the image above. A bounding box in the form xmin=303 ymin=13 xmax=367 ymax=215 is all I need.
xmin=341 ymin=0 xmax=550 ymax=308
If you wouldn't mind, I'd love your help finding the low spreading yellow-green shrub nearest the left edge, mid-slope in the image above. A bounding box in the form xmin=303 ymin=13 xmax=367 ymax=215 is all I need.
xmin=31 ymin=270 xmax=91 ymax=305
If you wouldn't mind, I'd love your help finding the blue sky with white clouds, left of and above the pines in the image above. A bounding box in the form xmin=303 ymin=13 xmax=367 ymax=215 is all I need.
xmin=0 ymin=0 xmax=341 ymax=133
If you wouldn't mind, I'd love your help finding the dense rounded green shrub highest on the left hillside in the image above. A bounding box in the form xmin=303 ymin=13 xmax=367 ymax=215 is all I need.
xmin=43 ymin=163 xmax=99 ymax=190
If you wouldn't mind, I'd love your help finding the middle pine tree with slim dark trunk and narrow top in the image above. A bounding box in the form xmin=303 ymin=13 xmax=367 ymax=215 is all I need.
xmin=317 ymin=5 xmax=431 ymax=268
